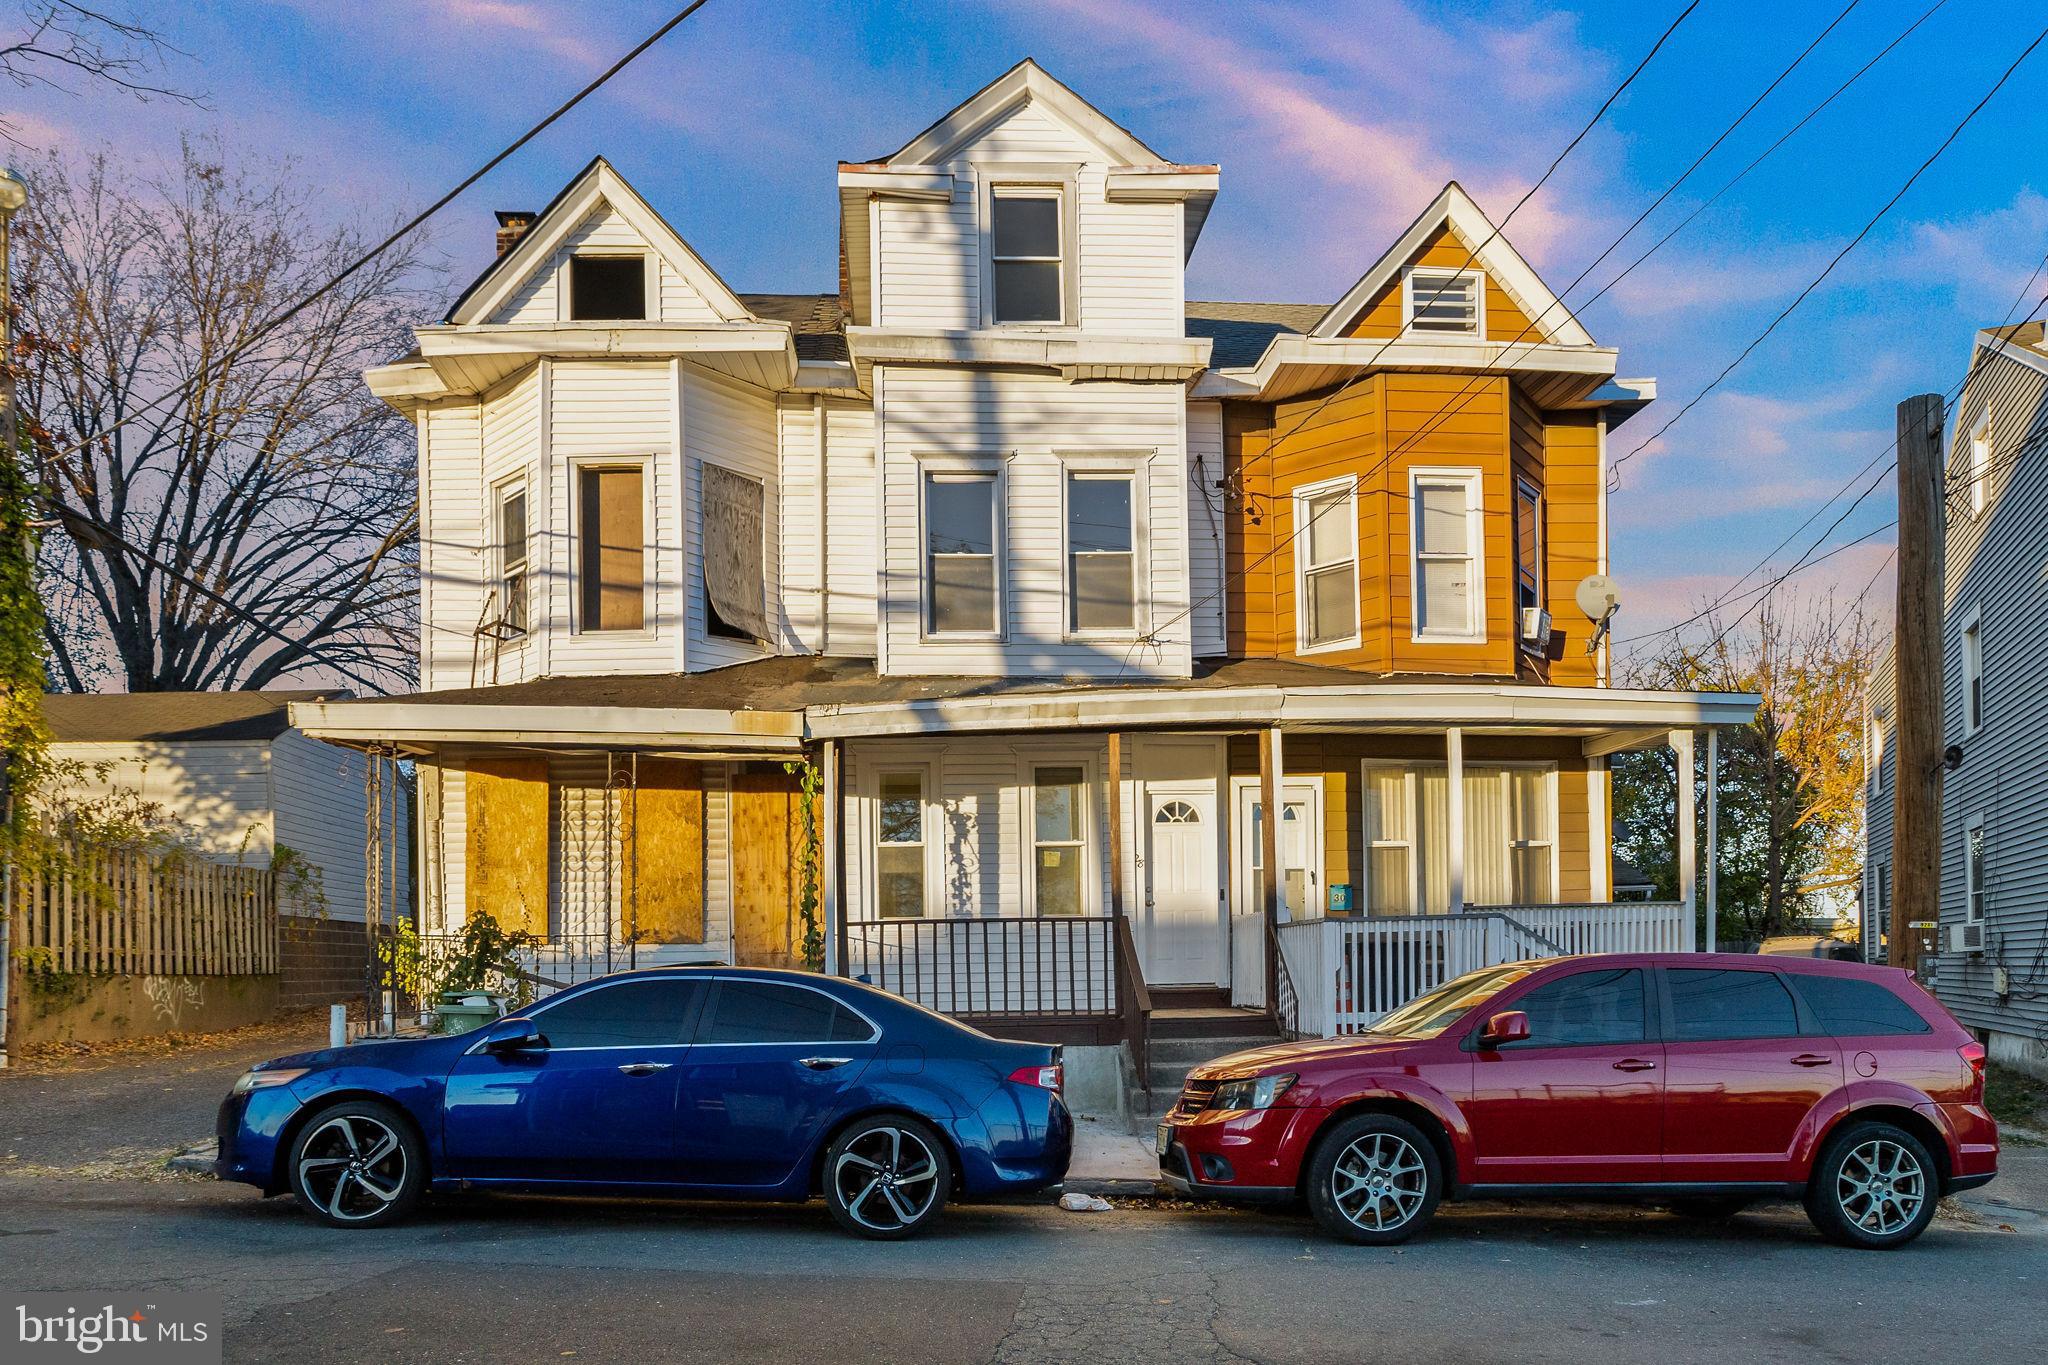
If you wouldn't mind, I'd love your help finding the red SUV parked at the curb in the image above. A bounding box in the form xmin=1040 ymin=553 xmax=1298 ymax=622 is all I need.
xmin=1159 ymin=954 xmax=1999 ymax=1248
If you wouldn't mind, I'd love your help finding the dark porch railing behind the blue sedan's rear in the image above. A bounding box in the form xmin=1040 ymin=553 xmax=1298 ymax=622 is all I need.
xmin=846 ymin=915 xmax=1122 ymax=1017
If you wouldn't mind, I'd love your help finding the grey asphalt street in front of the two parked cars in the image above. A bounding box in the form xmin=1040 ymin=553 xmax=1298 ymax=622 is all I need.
xmin=0 ymin=1031 xmax=2048 ymax=1365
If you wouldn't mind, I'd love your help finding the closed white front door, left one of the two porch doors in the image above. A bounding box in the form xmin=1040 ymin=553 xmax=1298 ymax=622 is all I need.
xmin=1139 ymin=782 xmax=1223 ymax=986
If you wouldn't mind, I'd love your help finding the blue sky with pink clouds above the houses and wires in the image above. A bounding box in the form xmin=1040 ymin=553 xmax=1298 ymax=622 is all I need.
xmin=16 ymin=0 xmax=2048 ymax=663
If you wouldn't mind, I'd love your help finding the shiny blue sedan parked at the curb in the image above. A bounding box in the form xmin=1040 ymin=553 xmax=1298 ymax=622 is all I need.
xmin=215 ymin=968 xmax=1073 ymax=1238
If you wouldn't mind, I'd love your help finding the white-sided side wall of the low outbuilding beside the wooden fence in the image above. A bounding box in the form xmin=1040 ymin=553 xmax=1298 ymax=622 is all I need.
xmin=270 ymin=731 xmax=414 ymax=921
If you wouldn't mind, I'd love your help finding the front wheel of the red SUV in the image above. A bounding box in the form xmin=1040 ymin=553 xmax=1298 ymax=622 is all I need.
xmin=1309 ymin=1113 xmax=1444 ymax=1246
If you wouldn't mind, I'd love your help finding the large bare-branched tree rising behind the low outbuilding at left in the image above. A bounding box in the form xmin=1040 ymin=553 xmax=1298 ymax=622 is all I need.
xmin=16 ymin=143 xmax=422 ymax=692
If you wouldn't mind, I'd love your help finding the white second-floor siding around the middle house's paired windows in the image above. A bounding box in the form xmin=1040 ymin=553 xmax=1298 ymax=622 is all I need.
xmin=874 ymin=366 xmax=1192 ymax=677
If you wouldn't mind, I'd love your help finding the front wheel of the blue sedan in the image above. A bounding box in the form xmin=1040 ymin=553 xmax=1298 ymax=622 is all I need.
xmin=291 ymin=1099 xmax=426 ymax=1228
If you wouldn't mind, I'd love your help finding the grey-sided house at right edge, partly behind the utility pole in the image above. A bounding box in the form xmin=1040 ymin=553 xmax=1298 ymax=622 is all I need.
xmin=1862 ymin=321 xmax=2048 ymax=1074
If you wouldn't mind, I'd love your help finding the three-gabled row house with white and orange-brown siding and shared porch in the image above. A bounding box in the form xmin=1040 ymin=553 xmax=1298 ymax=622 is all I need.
xmin=299 ymin=61 xmax=1755 ymax=1113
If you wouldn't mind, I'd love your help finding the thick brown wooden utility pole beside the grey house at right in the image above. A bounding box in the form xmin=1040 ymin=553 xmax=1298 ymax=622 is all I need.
xmin=1888 ymin=393 xmax=1946 ymax=976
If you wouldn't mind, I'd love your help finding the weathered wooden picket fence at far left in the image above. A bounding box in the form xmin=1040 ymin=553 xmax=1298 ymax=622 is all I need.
xmin=12 ymin=847 xmax=279 ymax=976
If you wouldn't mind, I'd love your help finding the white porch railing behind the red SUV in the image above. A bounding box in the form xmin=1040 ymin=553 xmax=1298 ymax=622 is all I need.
xmin=1231 ymin=900 xmax=1692 ymax=1038
